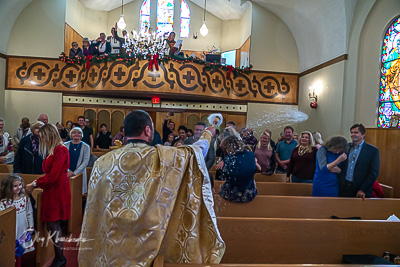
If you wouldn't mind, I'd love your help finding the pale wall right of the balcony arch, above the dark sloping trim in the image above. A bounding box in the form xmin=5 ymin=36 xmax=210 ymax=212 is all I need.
xmin=251 ymin=0 xmax=357 ymax=71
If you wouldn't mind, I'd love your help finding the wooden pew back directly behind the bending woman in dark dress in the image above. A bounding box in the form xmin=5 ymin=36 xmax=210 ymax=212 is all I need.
xmin=214 ymin=181 xmax=312 ymax=196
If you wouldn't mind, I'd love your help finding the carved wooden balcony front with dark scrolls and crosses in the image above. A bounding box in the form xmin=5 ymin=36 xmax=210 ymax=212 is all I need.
xmin=7 ymin=57 xmax=298 ymax=104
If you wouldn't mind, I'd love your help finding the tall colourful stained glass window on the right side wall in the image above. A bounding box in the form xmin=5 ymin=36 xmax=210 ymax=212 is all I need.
xmin=378 ymin=17 xmax=400 ymax=128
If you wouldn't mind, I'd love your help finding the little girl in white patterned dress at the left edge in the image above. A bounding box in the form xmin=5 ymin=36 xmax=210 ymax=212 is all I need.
xmin=0 ymin=173 xmax=35 ymax=267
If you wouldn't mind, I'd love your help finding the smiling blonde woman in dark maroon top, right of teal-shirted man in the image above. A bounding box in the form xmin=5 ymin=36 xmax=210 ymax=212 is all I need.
xmin=286 ymin=131 xmax=318 ymax=183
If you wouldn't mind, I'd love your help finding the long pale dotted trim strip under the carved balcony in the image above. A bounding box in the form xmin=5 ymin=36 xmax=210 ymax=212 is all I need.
xmin=63 ymin=96 xmax=247 ymax=113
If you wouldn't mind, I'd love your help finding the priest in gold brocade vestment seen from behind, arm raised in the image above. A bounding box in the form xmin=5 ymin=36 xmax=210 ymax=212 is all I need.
xmin=78 ymin=110 xmax=225 ymax=267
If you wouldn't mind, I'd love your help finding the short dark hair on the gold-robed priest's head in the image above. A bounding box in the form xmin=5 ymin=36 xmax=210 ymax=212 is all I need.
xmin=124 ymin=110 xmax=153 ymax=137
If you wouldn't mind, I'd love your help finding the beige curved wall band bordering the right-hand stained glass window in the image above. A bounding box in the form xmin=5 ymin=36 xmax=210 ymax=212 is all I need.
xmin=350 ymin=0 xmax=400 ymax=127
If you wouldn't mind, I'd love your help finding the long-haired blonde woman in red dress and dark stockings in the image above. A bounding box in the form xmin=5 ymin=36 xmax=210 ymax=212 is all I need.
xmin=26 ymin=123 xmax=71 ymax=266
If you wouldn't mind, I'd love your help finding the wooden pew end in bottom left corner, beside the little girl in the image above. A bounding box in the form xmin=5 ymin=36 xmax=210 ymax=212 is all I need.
xmin=0 ymin=207 xmax=16 ymax=267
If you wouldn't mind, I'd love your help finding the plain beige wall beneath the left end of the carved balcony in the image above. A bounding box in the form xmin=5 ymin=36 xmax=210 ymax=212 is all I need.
xmin=5 ymin=90 xmax=62 ymax=135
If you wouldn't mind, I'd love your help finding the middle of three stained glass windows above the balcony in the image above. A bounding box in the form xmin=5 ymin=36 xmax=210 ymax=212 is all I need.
xmin=157 ymin=0 xmax=174 ymax=34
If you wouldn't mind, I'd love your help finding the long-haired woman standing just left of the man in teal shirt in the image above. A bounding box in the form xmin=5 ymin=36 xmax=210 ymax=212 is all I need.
xmin=254 ymin=130 xmax=276 ymax=175
